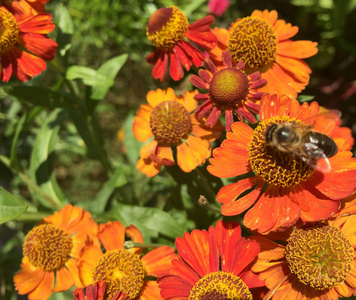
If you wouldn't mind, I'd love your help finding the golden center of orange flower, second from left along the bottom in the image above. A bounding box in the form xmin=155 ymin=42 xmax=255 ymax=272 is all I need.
xmin=93 ymin=250 xmax=145 ymax=299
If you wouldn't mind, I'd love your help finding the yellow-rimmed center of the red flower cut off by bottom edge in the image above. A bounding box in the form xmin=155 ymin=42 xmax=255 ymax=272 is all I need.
xmin=188 ymin=272 xmax=252 ymax=300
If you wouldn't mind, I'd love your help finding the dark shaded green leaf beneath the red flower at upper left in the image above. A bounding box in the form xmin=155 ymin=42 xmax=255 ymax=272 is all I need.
xmin=4 ymin=85 xmax=72 ymax=108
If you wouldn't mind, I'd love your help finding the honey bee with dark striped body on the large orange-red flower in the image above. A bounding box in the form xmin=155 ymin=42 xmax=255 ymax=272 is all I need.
xmin=265 ymin=111 xmax=341 ymax=173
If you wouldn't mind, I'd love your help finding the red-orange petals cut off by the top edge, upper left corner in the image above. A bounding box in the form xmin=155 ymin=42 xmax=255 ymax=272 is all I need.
xmin=1 ymin=0 xmax=49 ymax=15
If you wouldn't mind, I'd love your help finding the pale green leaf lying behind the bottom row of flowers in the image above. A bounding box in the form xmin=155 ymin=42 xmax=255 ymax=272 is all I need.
xmin=108 ymin=203 xmax=189 ymax=239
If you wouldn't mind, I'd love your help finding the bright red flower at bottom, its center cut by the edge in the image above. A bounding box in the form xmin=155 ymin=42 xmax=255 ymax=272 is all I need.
xmin=158 ymin=221 xmax=264 ymax=300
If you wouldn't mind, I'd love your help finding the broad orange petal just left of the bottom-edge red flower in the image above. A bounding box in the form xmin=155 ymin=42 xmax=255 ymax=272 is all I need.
xmin=141 ymin=246 xmax=178 ymax=277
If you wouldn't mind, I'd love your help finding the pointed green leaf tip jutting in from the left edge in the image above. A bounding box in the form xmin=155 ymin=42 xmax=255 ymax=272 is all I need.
xmin=0 ymin=187 xmax=27 ymax=224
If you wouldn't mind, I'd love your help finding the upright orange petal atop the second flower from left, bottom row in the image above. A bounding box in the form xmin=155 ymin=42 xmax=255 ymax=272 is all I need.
xmin=98 ymin=221 xmax=125 ymax=251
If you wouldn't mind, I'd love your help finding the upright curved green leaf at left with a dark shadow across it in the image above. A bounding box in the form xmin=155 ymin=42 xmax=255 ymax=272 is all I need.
xmin=30 ymin=109 xmax=67 ymax=208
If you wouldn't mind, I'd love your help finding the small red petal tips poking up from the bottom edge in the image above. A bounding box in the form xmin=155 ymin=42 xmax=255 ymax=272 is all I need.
xmin=73 ymin=280 xmax=128 ymax=300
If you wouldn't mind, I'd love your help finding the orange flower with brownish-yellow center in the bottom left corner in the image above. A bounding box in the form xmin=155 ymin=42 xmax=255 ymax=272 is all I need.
xmin=14 ymin=204 xmax=99 ymax=300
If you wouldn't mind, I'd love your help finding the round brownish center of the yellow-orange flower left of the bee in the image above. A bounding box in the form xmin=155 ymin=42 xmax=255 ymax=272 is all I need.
xmin=150 ymin=101 xmax=192 ymax=146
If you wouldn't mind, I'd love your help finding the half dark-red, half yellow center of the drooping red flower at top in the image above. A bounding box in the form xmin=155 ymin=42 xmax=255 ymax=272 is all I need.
xmin=147 ymin=6 xmax=189 ymax=49
